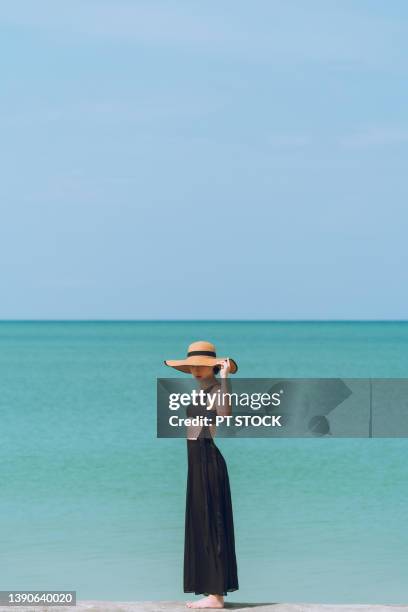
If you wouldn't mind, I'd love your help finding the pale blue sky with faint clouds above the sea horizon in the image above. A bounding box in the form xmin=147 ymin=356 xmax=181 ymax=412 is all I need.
xmin=0 ymin=0 xmax=408 ymax=319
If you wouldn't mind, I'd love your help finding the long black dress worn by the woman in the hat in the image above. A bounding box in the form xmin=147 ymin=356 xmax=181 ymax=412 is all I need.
xmin=184 ymin=385 xmax=238 ymax=595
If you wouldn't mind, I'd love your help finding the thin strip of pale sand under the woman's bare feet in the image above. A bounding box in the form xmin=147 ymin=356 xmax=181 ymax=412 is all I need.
xmin=0 ymin=601 xmax=408 ymax=612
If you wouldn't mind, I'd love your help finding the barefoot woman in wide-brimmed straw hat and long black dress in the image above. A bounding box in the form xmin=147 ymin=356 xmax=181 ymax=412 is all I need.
xmin=164 ymin=341 xmax=238 ymax=608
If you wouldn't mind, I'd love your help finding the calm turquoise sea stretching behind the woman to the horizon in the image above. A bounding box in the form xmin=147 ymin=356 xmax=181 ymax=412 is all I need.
xmin=0 ymin=322 xmax=408 ymax=603
